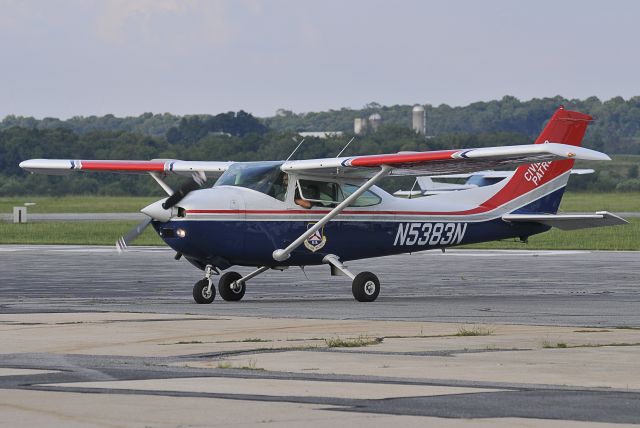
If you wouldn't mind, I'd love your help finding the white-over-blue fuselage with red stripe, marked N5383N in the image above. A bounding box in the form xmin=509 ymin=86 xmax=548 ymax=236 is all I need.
xmin=153 ymin=168 xmax=566 ymax=269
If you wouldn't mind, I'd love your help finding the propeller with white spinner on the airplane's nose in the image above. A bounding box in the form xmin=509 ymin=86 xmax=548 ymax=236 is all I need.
xmin=116 ymin=171 xmax=207 ymax=253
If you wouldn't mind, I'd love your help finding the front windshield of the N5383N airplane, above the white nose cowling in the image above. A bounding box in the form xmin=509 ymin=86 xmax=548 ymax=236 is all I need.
xmin=214 ymin=162 xmax=285 ymax=199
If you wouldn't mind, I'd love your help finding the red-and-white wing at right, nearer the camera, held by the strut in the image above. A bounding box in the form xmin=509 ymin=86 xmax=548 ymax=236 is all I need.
xmin=282 ymin=143 xmax=611 ymax=178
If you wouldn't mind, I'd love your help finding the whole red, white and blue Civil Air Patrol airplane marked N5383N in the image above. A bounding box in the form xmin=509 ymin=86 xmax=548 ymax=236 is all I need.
xmin=20 ymin=106 xmax=627 ymax=304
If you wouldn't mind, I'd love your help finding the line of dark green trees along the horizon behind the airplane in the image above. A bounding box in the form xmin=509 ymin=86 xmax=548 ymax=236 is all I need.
xmin=0 ymin=97 xmax=640 ymax=196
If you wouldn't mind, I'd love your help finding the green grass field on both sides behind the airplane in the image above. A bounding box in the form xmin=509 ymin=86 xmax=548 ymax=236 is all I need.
xmin=0 ymin=192 xmax=640 ymax=250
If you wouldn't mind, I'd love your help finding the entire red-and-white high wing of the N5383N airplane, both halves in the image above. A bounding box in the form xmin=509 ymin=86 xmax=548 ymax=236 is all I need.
xmin=20 ymin=143 xmax=610 ymax=178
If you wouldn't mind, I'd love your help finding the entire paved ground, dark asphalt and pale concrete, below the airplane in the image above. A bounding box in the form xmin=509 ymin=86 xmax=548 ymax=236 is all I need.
xmin=0 ymin=246 xmax=640 ymax=426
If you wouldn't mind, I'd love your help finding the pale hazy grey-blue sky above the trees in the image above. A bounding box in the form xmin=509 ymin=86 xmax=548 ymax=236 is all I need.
xmin=0 ymin=0 xmax=640 ymax=118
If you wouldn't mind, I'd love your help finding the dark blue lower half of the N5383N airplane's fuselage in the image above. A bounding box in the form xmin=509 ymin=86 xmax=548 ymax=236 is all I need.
xmin=153 ymin=218 xmax=549 ymax=268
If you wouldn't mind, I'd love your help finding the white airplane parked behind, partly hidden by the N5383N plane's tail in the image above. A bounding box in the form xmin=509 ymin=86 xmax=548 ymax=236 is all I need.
xmin=393 ymin=168 xmax=595 ymax=198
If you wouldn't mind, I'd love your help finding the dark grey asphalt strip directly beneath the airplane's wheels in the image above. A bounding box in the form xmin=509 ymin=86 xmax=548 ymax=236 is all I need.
xmin=0 ymin=245 xmax=640 ymax=326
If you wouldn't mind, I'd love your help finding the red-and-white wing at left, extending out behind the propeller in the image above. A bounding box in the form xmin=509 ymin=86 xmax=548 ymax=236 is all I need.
xmin=20 ymin=159 xmax=233 ymax=177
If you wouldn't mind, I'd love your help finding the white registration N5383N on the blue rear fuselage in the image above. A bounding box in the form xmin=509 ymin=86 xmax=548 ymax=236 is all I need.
xmin=393 ymin=223 xmax=467 ymax=246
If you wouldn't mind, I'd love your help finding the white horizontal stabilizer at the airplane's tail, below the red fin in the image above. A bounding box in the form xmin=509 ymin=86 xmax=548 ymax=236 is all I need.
xmin=502 ymin=211 xmax=629 ymax=230
